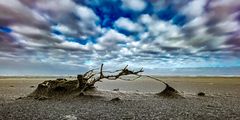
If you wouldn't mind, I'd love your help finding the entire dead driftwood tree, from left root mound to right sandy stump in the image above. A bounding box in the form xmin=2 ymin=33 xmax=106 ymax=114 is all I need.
xmin=31 ymin=64 xmax=180 ymax=97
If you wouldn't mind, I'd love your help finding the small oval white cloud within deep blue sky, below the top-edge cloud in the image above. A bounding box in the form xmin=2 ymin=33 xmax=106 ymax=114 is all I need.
xmin=114 ymin=17 xmax=143 ymax=32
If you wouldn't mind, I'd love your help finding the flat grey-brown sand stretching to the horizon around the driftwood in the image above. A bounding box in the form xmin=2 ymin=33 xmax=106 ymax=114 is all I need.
xmin=0 ymin=77 xmax=240 ymax=120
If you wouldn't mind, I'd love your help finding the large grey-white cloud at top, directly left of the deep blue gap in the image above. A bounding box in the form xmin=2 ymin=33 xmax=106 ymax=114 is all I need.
xmin=29 ymin=0 xmax=101 ymax=37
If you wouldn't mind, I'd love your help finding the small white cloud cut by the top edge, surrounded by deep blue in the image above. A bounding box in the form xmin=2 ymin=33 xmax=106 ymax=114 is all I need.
xmin=122 ymin=0 xmax=147 ymax=11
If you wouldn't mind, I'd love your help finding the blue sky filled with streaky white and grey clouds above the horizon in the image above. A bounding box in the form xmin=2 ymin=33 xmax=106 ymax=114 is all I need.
xmin=0 ymin=0 xmax=240 ymax=75
